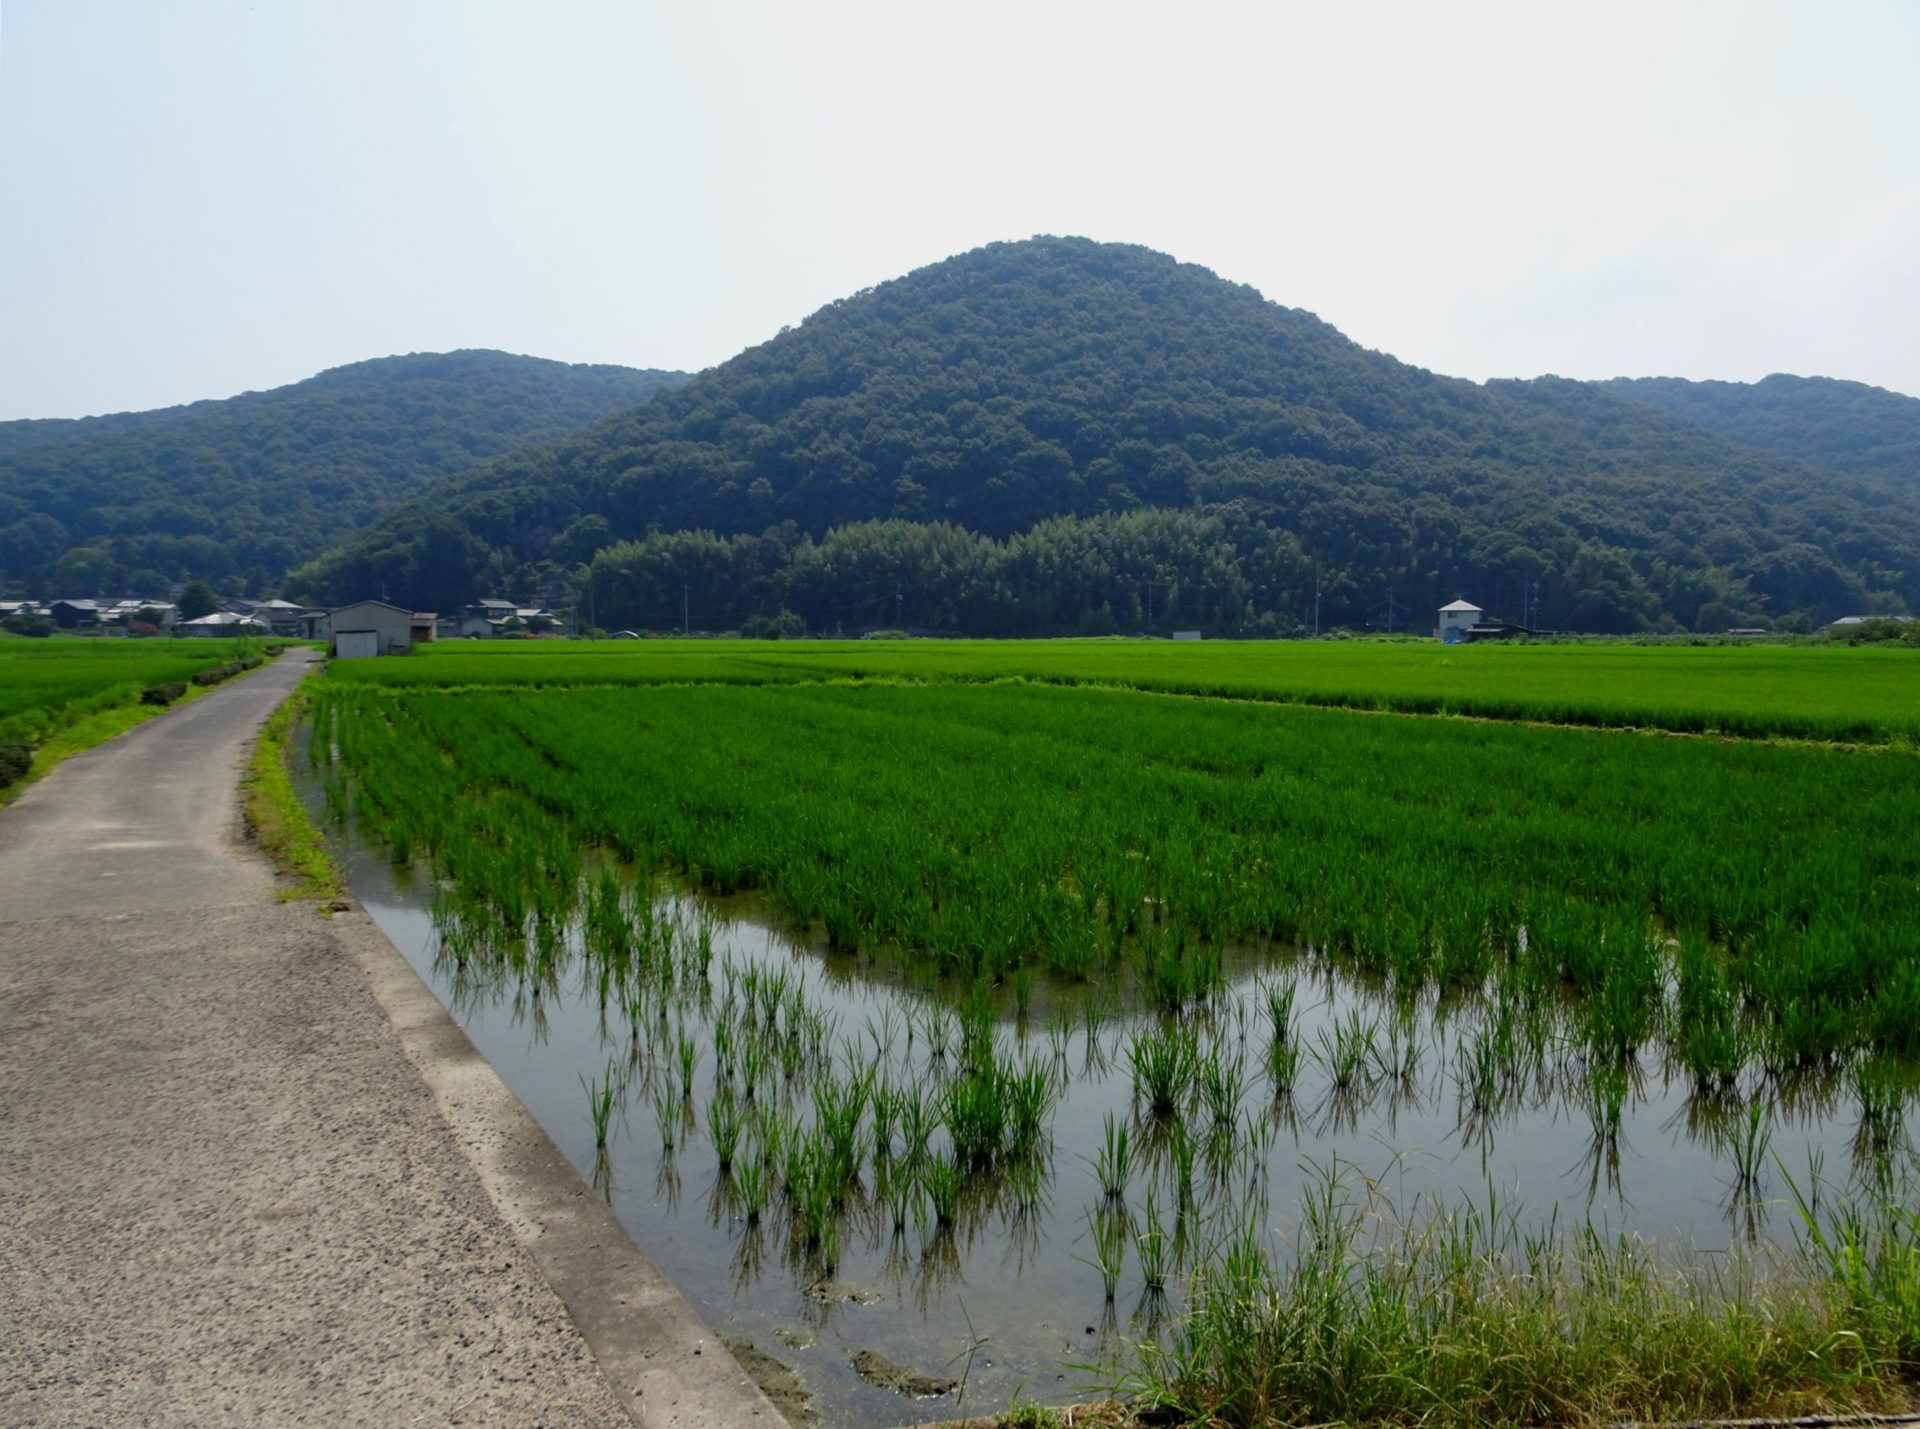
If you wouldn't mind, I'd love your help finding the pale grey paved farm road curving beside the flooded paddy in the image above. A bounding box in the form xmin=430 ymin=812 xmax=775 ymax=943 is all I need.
xmin=0 ymin=651 xmax=774 ymax=1425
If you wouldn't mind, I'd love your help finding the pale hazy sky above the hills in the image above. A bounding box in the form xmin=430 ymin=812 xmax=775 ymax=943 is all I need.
xmin=0 ymin=0 xmax=1920 ymax=417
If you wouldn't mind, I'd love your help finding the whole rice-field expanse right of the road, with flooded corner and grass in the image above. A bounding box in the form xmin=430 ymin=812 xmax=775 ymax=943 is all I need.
xmin=307 ymin=642 xmax=1920 ymax=1425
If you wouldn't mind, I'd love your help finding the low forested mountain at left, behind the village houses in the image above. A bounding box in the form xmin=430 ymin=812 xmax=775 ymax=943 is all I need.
xmin=0 ymin=351 xmax=685 ymax=595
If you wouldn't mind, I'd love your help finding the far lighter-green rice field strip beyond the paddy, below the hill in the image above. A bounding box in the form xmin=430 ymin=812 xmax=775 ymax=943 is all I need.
xmin=328 ymin=640 xmax=1920 ymax=743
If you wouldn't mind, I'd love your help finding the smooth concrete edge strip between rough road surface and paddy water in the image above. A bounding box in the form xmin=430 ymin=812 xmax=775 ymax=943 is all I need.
xmin=330 ymin=887 xmax=785 ymax=1429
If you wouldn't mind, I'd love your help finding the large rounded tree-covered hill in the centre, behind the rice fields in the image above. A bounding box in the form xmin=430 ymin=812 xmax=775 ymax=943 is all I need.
xmin=290 ymin=238 xmax=1920 ymax=632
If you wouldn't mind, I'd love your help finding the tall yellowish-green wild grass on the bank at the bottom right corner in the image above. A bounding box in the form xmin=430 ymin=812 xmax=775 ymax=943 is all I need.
xmin=1117 ymin=1174 xmax=1920 ymax=1427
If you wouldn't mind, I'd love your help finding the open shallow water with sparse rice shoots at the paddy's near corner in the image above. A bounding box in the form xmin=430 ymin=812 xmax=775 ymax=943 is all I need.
xmin=318 ymin=834 xmax=1905 ymax=1425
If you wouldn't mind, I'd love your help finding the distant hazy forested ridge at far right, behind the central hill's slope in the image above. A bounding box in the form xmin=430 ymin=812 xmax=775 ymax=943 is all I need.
xmin=1607 ymin=373 xmax=1920 ymax=494
